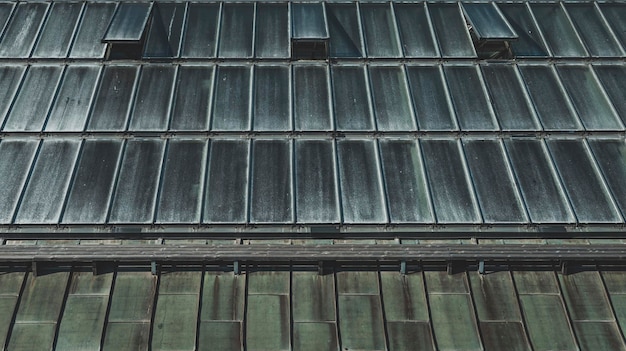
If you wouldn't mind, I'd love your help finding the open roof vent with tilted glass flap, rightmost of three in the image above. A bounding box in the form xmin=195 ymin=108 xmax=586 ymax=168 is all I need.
xmin=461 ymin=3 xmax=519 ymax=59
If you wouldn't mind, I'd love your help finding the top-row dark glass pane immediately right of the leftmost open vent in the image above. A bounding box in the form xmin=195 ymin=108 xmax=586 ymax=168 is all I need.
xmin=143 ymin=3 xmax=185 ymax=57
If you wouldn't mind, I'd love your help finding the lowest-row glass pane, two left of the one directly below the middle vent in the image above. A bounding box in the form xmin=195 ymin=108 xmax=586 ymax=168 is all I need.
xmin=203 ymin=140 xmax=250 ymax=223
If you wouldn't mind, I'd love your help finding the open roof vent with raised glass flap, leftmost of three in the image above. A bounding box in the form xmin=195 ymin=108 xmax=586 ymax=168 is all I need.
xmin=102 ymin=3 xmax=153 ymax=60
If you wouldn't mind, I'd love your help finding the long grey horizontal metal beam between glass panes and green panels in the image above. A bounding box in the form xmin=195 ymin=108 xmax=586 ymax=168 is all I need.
xmin=0 ymin=244 xmax=626 ymax=263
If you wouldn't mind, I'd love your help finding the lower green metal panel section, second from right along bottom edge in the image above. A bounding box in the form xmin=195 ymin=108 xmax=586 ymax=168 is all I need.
xmin=519 ymin=295 xmax=577 ymax=350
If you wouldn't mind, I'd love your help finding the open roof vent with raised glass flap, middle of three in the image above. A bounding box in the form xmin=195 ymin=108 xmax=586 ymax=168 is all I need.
xmin=291 ymin=3 xmax=329 ymax=60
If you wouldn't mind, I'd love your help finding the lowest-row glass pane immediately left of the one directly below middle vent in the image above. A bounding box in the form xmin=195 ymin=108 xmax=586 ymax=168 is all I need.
xmin=250 ymin=140 xmax=293 ymax=223
